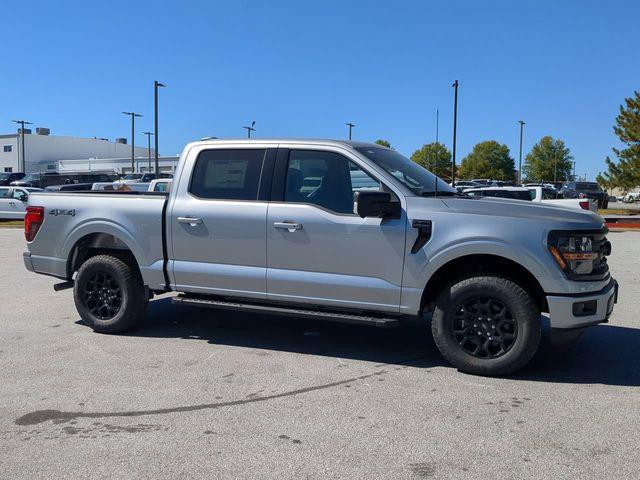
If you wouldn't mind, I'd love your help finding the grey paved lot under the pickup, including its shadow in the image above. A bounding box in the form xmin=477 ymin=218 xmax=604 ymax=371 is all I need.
xmin=0 ymin=229 xmax=640 ymax=479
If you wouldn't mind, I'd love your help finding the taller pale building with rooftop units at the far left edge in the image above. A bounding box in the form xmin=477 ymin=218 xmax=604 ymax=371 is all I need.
xmin=0 ymin=128 xmax=154 ymax=173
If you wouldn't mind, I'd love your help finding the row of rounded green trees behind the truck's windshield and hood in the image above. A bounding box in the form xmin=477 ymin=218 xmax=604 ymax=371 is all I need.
xmin=376 ymin=135 xmax=573 ymax=182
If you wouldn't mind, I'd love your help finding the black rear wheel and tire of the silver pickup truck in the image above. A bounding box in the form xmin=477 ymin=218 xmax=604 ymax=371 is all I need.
xmin=73 ymin=255 xmax=148 ymax=333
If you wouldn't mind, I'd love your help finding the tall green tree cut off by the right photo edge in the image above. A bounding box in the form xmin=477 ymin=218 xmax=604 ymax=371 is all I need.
xmin=596 ymin=91 xmax=640 ymax=190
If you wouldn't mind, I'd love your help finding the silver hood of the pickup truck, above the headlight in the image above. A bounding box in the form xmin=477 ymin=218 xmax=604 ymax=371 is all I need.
xmin=432 ymin=197 xmax=604 ymax=229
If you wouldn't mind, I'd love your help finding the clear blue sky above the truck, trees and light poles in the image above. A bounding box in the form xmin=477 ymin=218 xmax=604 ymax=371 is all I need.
xmin=0 ymin=0 xmax=640 ymax=178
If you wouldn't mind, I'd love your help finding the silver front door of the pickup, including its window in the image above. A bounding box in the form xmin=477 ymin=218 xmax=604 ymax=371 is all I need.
xmin=267 ymin=150 xmax=406 ymax=312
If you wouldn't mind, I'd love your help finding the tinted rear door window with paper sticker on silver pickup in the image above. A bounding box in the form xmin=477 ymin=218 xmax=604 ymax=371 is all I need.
xmin=189 ymin=149 xmax=265 ymax=200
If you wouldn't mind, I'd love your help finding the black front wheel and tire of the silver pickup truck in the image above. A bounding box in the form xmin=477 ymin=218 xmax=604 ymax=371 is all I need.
xmin=431 ymin=275 xmax=542 ymax=376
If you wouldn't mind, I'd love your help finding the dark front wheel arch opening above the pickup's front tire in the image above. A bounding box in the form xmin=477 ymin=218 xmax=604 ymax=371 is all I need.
xmin=420 ymin=254 xmax=548 ymax=312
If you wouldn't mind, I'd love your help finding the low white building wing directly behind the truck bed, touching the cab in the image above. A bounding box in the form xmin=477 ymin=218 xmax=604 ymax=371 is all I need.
xmin=49 ymin=156 xmax=179 ymax=173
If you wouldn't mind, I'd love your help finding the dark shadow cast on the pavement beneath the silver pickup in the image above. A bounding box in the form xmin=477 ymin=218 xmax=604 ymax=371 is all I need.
xmin=112 ymin=298 xmax=640 ymax=386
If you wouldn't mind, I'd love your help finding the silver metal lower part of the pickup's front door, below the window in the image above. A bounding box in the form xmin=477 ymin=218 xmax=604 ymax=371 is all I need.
xmin=267 ymin=203 xmax=406 ymax=312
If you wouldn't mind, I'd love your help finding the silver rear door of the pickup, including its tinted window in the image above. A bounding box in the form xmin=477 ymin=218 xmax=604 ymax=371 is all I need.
xmin=169 ymin=149 xmax=275 ymax=299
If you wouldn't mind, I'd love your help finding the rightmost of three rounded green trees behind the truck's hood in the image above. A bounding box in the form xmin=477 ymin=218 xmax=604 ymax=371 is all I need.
xmin=522 ymin=135 xmax=573 ymax=182
